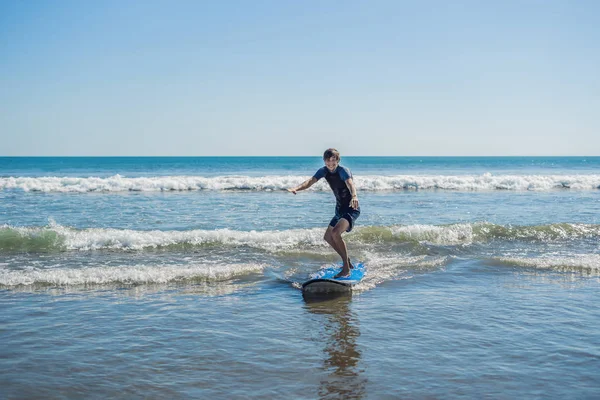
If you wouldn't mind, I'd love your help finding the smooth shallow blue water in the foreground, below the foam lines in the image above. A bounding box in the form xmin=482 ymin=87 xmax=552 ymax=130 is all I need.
xmin=0 ymin=261 xmax=600 ymax=399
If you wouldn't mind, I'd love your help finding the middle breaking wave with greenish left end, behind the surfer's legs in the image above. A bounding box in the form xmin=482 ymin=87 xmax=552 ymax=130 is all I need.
xmin=0 ymin=222 xmax=600 ymax=252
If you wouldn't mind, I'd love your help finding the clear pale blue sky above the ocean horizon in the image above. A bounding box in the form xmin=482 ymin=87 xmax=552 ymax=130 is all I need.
xmin=0 ymin=0 xmax=600 ymax=156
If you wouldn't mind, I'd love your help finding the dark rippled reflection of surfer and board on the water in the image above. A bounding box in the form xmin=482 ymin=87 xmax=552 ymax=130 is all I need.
xmin=303 ymin=293 xmax=367 ymax=399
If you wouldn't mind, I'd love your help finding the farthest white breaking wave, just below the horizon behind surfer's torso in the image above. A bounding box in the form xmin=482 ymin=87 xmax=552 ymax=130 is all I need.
xmin=0 ymin=173 xmax=600 ymax=193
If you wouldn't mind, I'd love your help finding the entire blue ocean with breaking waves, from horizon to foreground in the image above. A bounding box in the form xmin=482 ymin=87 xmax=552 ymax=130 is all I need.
xmin=0 ymin=156 xmax=600 ymax=399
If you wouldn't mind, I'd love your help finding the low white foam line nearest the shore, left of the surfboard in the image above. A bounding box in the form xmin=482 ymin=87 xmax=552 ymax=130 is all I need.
xmin=0 ymin=264 xmax=265 ymax=286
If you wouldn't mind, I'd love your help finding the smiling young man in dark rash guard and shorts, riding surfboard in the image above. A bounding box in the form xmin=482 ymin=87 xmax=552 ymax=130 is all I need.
xmin=288 ymin=149 xmax=360 ymax=278
